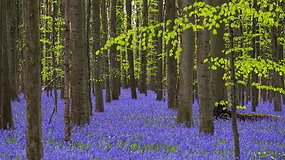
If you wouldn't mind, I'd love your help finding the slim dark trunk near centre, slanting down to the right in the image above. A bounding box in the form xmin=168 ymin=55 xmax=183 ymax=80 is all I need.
xmin=126 ymin=0 xmax=137 ymax=99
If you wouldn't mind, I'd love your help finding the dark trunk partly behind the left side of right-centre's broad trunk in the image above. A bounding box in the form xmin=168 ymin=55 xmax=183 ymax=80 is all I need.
xmin=165 ymin=0 xmax=177 ymax=109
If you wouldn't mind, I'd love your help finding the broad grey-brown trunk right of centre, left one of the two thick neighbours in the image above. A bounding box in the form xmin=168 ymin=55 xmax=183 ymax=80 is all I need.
xmin=177 ymin=0 xmax=195 ymax=127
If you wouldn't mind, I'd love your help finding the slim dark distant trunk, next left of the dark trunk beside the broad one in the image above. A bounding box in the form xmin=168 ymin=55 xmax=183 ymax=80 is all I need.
xmin=156 ymin=0 xmax=163 ymax=101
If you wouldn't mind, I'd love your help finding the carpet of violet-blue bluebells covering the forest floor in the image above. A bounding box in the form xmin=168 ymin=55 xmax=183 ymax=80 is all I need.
xmin=0 ymin=90 xmax=285 ymax=160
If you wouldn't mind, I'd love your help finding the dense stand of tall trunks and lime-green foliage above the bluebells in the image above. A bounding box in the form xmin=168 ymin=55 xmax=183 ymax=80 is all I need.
xmin=0 ymin=0 xmax=285 ymax=157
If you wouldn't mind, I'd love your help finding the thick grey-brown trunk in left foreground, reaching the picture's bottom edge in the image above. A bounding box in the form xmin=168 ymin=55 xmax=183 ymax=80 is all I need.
xmin=23 ymin=0 xmax=43 ymax=160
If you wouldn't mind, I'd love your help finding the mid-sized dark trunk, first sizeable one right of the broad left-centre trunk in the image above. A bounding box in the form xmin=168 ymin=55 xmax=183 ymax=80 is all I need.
xmin=93 ymin=0 xmax=104 ymax=112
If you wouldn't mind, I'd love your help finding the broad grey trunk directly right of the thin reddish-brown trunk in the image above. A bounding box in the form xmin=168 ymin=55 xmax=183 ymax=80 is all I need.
xmin=71 ymin=0 xmax=90 ymax=125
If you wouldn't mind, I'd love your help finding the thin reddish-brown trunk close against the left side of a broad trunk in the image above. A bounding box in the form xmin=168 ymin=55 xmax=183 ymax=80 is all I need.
xmin=64 ymin=0 xmax=71 ymax=141
